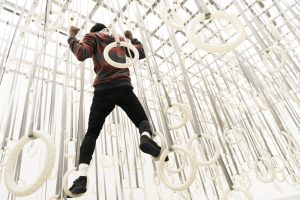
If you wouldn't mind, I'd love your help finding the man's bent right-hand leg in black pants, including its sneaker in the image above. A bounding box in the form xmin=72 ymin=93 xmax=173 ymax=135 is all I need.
xmin=116 ymin=88 xmax=165 ymax=157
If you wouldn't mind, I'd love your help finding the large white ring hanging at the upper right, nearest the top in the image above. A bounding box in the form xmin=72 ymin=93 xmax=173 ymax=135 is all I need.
xmin=187 ymin=11 xmax=246 ymax=53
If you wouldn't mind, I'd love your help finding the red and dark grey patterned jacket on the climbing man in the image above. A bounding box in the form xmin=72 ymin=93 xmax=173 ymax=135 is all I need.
xmin=68 ymin=31 xmax=145 ymax=90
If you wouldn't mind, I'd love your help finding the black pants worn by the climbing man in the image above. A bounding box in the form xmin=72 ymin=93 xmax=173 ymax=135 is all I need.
xmin=79 ymin=86 xmax=152 ymax=164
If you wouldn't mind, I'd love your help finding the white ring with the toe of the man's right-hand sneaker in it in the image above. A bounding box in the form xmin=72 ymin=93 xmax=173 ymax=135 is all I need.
xmin=157 ymin=145 xmax=197 ymax=191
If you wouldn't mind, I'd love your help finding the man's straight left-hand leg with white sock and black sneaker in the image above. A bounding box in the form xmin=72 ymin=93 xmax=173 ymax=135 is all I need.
xmin=70 ymin=91 xmax=115 ymax=197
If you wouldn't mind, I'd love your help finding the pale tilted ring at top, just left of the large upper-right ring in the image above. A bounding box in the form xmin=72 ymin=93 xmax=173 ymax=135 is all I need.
xmin=158 ymin=8 xmax=184 ymax=30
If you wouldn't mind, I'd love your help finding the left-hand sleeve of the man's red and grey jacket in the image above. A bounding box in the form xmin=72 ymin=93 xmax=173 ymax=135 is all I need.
xmin=68 ymin=33 xmax=97 ymax=61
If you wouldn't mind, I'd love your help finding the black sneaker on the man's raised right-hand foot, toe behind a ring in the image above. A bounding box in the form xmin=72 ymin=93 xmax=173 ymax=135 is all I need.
xmin=140 ymin=135 xmax=169 ymax=161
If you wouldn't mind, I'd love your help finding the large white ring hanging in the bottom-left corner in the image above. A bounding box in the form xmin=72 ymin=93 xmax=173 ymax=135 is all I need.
xmin=4 ymin=131 xmax=55 ymax=196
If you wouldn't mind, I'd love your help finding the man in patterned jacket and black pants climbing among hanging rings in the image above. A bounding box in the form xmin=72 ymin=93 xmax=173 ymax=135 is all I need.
xmin=68 ymin=23 xmax=166 ymax=194
